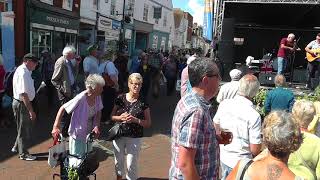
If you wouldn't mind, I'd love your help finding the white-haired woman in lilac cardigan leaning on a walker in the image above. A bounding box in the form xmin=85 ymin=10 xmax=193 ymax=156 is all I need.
xmin=51 ymin=74 xmax=105 ymax=162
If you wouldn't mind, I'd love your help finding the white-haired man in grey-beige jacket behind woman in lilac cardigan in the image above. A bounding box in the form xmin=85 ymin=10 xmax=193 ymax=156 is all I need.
xmin=51 ymin=46 xmax=79 ymax=137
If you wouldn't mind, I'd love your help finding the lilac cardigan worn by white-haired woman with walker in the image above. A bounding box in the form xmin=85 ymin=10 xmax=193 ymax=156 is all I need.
xmin=63 ymin=90 xmax=103 ymax=141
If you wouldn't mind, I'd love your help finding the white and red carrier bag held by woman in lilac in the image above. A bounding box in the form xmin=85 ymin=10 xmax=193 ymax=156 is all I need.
xmin=48 ymin=136 xmax=67 ymax=168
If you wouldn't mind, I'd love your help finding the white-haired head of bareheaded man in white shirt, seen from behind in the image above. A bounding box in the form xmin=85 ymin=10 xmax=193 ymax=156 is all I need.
xmin=238 ymin=74 xmax=260 ymax=98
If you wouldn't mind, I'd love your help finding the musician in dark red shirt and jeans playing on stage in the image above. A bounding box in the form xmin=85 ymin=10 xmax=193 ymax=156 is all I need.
xmin=277 ymin=33 xmax=300 ymax=74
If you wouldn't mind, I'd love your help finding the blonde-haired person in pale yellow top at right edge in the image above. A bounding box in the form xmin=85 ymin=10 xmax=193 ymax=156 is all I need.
xmin=288 ymin=100 xmax=320 ymax=180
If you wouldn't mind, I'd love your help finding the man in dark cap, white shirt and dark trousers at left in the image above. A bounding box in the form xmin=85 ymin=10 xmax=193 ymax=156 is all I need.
xmin=11 ymin=53 xmax=38 ymax=161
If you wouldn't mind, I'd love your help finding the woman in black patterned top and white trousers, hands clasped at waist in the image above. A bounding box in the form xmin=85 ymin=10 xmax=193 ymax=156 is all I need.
xmin=111 ymin=73 xmax=151 ymax=180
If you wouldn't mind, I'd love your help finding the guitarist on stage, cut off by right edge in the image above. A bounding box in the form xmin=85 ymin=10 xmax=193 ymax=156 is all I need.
xmin=305 ymin=33 xmax=320 ymax=89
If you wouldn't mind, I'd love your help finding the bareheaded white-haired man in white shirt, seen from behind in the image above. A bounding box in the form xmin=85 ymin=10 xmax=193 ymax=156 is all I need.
xmin=213 ymin=74 xmax=261 ymax=179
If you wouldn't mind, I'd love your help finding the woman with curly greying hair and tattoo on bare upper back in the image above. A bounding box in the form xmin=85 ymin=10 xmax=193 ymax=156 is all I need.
xmin=227 ymin=111 xmax=302 ymax=180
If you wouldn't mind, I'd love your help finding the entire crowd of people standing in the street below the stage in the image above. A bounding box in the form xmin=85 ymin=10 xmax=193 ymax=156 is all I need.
xmin=0 ymin=41 xmax=320 ymax=180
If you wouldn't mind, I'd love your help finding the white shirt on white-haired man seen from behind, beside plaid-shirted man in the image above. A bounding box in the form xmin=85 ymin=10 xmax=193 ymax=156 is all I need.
xmin=213 ymin=95 xmax=261 ymax=168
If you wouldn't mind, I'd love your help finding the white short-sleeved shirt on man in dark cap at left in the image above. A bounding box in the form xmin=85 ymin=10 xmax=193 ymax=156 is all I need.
xmin=12 ymin=63 xmax=36 ymax=101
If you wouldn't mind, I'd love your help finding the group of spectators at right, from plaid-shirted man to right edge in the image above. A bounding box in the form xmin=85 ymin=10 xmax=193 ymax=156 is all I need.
xmin=169 ymin=58 xmax=320 ymax=179
